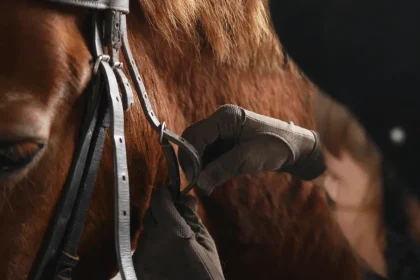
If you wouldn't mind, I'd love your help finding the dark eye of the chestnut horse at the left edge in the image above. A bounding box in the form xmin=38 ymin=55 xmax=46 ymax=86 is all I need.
xmin=0 ymin=142 xmax=44 ymax=177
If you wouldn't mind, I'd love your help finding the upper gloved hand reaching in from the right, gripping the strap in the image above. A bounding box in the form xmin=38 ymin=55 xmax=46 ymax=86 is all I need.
xmin=179 ymin=105 xmax=325 ymax=195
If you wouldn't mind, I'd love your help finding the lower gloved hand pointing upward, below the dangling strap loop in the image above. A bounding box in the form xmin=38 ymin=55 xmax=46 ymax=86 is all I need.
xmin=133 ymin=188 xmax=224 ymax=280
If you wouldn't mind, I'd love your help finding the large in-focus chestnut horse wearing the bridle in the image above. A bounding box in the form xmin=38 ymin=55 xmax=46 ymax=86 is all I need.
xmin=0 ymin=0 xmax=359 ymax=280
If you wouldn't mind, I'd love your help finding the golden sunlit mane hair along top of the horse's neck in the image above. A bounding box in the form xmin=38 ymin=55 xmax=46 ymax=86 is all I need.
xmin=140 ymin=0 xmax=283 ymax=67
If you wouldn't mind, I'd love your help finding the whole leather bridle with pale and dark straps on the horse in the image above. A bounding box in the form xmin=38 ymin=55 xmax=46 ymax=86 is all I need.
xmin=29 ymin=0 xmax=201 ymax=280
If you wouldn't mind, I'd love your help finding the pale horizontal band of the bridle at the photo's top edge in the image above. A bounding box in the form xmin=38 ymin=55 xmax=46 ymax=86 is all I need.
xmin=46 ymin=0 xmax=130 ymax=14
